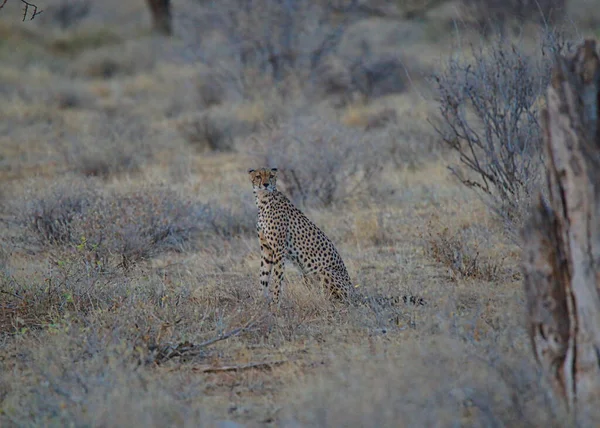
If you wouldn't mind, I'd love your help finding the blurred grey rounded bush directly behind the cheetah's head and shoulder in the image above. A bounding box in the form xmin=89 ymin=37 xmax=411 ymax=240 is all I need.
xmin=250 ymin=116 xmax=382 ymax=205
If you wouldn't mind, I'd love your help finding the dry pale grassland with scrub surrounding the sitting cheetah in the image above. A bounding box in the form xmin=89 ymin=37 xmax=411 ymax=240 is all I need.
xmin=0 ymin=0 xmax=584 ymax=427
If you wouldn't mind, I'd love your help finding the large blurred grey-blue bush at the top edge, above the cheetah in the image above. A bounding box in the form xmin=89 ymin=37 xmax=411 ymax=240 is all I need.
xmin=179 ymin=0 xmax=355 ymax=96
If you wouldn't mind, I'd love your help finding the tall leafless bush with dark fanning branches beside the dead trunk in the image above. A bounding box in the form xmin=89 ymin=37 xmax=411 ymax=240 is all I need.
xmin=434 ymin=33 xmax=567 ymax=231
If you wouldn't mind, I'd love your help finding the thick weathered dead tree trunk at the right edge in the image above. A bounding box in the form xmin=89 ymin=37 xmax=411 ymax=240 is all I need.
xmin=523 ymin=40 xmax=600 ymax=427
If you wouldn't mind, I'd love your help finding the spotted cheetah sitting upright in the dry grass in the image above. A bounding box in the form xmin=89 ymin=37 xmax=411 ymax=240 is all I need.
xmin=248 ymin=168 xmax=425 ymax=306
